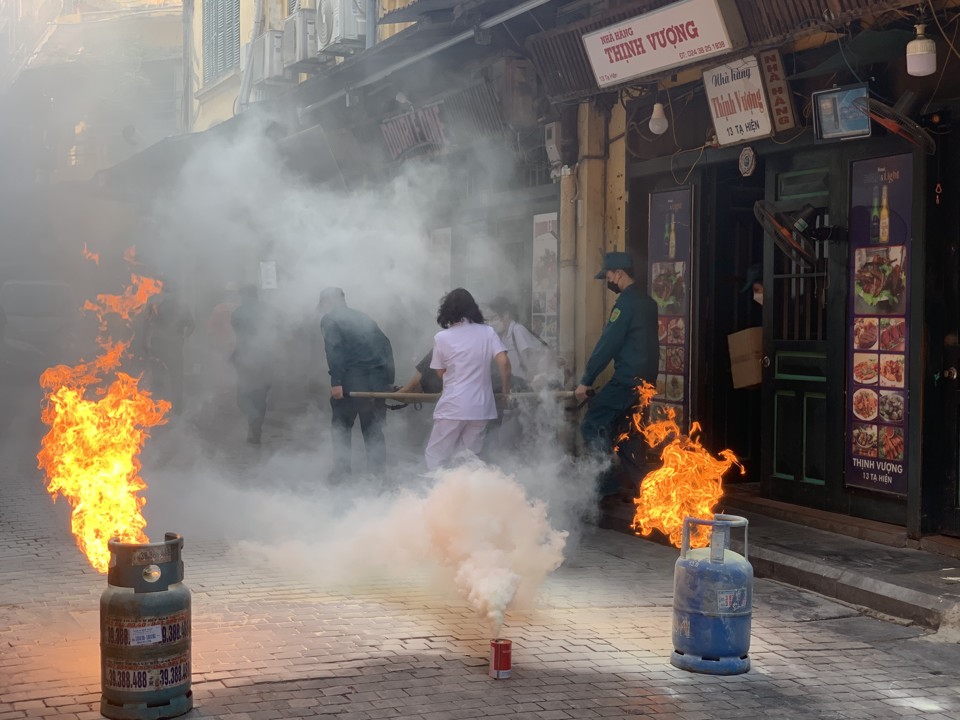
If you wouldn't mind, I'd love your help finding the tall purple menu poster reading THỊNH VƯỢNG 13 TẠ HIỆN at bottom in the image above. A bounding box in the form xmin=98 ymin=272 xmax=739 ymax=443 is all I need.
xmin=846 ymin=155 xmax=913 ymax=495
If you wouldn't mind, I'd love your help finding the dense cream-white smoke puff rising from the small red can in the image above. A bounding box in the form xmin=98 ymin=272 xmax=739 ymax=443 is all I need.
xmin=231 ymin=462 xmax=568 ymax=636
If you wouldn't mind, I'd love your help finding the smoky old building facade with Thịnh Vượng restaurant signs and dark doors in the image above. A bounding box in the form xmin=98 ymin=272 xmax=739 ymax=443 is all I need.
xmin=103 ymin=0 xmax=960 ymax=537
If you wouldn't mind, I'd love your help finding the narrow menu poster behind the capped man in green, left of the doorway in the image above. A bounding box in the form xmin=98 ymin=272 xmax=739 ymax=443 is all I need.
xmin=647 ymin=188 xmax=693 ymax=429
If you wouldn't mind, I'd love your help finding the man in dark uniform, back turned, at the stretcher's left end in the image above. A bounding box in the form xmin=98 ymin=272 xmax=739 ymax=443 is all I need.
xmin=317 ymin=287 xmax=395 ymax=480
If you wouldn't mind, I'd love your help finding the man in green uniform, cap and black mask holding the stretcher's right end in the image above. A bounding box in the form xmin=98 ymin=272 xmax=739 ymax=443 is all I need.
xmin=576 ymin=252 xmax=659 ymax=496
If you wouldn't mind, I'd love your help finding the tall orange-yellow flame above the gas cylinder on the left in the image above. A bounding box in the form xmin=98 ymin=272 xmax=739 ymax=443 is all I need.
xmin=37 ymin=258 xmax=170 ymax=573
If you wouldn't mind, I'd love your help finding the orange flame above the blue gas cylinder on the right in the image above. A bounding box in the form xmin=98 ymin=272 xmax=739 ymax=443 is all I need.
xmin=617 ymin=383 xmax=745 ymax=547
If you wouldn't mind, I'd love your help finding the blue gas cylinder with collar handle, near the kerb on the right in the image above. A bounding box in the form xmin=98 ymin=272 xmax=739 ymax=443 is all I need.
xmin=670 ymin=515 xmax=753 ymax=675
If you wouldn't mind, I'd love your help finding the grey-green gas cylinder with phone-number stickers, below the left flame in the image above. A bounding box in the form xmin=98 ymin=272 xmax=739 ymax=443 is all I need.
xmin=100 ymin=533 xmax=193 ymax=720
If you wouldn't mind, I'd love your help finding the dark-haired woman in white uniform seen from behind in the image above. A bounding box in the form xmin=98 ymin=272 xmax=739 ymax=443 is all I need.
xmin=424 ymin=288 xmax=510 ymax=470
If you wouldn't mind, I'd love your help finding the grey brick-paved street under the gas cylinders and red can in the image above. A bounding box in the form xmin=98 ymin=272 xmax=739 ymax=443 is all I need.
xmin=0 ymin=376 xmax=960 ymax=720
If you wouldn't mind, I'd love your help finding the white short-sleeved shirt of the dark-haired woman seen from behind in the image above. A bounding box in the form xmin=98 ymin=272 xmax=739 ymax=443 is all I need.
xmin=430 ymin=320 xmax=506 ymax=420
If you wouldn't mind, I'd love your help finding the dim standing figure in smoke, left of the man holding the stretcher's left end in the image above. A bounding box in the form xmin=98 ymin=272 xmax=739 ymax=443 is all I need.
xmin=230 ymin=285 xmax=275 ymax=445
